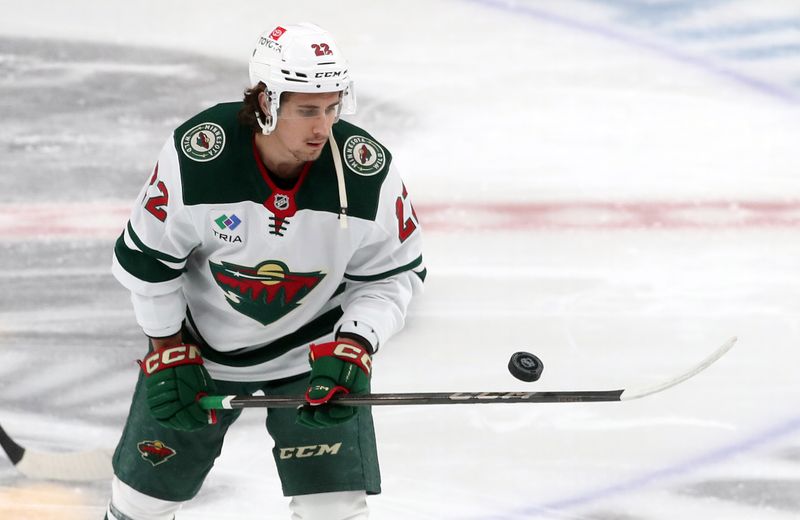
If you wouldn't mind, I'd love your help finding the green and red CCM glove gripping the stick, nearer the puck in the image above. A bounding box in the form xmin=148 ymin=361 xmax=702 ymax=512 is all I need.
xmin=297 ymin=340 xmax=372 ymax=428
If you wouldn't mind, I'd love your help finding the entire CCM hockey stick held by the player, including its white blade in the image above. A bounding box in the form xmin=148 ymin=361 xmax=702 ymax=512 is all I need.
xmin=200 ymin=337 xmax=737 ymax=410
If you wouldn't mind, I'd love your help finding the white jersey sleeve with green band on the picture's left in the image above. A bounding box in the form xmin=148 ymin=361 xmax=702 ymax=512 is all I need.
xmin=111 ymin=138 xmax=200 ymax=337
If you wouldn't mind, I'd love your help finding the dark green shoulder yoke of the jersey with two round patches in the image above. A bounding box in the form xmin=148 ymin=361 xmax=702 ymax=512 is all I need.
xmin=173 ymin=102 xmax=392 ymax=220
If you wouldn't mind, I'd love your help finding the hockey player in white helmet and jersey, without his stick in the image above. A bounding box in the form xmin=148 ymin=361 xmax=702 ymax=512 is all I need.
xmin=106 ymin=23 xmax=425 ymax=520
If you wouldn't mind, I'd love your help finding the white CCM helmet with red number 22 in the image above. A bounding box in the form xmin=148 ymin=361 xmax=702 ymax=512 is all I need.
xmin=250 ymin=23 xmax=356 ymax=134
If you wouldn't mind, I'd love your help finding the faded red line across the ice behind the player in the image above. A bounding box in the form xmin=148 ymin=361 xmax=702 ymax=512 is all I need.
xmin=0 ymin=200 xmax=800 ymax=239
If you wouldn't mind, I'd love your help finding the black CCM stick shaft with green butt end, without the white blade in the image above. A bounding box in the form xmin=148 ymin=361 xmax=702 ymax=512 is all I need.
xmin=200 ymin=390 xmax=624 ymax=409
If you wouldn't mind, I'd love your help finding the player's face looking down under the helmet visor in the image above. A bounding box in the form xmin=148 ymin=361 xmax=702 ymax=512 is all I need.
xmin=273 ymin=92 xmax=341 ymax=162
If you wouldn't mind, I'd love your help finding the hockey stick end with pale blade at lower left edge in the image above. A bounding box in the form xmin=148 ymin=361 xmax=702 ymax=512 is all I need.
xmin=0 ymin=426 xmax=113 ymax=481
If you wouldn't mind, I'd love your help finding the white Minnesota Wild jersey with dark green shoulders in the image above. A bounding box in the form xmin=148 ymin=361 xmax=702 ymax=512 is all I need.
xmin=112 ymin=103 xmax=426 ymax=381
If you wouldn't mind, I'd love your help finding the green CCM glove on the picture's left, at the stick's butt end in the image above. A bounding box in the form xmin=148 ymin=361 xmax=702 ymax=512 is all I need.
xmin=139 ymin=344 xmax=216 ymax=431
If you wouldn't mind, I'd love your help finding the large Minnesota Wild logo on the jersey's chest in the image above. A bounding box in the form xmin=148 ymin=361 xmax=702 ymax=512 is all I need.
xmin=208 ymin=260 xmax=325 ymax=325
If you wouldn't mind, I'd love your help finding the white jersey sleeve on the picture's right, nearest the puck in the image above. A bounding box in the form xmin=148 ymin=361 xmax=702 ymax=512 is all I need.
xmin=337 ymin=166 xmax=426 ymax=351
